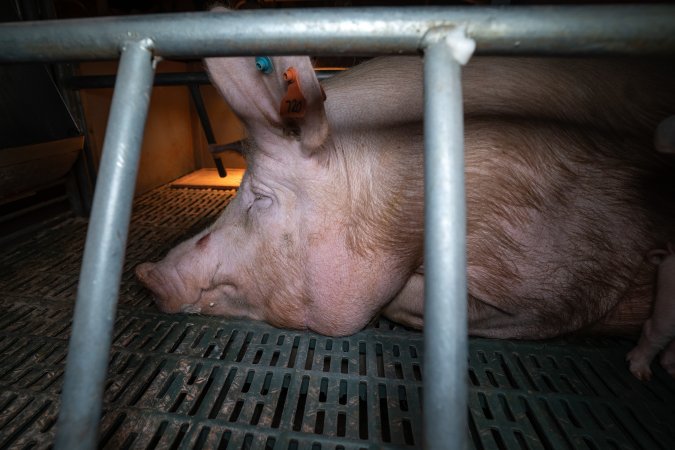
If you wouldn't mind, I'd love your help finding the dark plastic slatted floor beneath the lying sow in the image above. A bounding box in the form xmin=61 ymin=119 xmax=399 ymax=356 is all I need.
xmin=0 ymin=187 xmax=675 ymax=450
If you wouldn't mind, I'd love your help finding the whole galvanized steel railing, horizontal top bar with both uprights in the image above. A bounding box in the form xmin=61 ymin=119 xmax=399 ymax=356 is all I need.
xmin=0 ymin=5 xmax=675 ymax=449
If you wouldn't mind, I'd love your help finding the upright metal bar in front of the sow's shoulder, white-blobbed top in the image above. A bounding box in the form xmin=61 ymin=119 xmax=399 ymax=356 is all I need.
xmin=424 ymin=29 xmax=473 ymax=449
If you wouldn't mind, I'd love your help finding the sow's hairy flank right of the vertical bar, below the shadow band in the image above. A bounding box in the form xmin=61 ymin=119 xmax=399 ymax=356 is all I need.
xmin=466 ymin=124 xmax=656 ymax=338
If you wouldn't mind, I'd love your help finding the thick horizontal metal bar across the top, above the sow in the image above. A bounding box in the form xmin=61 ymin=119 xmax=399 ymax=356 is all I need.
xmin=0 ymin=4 xmax=675 ymax=61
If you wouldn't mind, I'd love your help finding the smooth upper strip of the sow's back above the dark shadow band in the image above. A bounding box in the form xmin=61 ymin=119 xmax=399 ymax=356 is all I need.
xmin=324 ymin=56 xmax=675 ymax=135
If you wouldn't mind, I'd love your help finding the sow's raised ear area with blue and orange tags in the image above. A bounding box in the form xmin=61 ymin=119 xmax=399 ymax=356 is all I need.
xmin=205 ymin=56 xmax=328 ymax=155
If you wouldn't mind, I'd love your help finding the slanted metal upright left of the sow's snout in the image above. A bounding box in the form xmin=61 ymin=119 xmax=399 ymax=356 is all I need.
xmin=56 ymin=40 xmax=154 ymax=450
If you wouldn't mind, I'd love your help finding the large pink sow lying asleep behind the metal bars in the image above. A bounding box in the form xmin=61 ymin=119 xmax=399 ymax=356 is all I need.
xmin=136 ymin=52 xmax=675 ymax=376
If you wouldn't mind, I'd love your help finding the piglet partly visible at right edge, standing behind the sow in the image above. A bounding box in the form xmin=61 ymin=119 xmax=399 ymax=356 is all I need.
xmin=626 ymin=243 xmax=675 ymax=380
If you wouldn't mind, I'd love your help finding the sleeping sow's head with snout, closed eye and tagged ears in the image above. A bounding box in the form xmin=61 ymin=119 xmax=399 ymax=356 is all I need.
xmin=136 ymin=53 xmax=421 ymax=335
